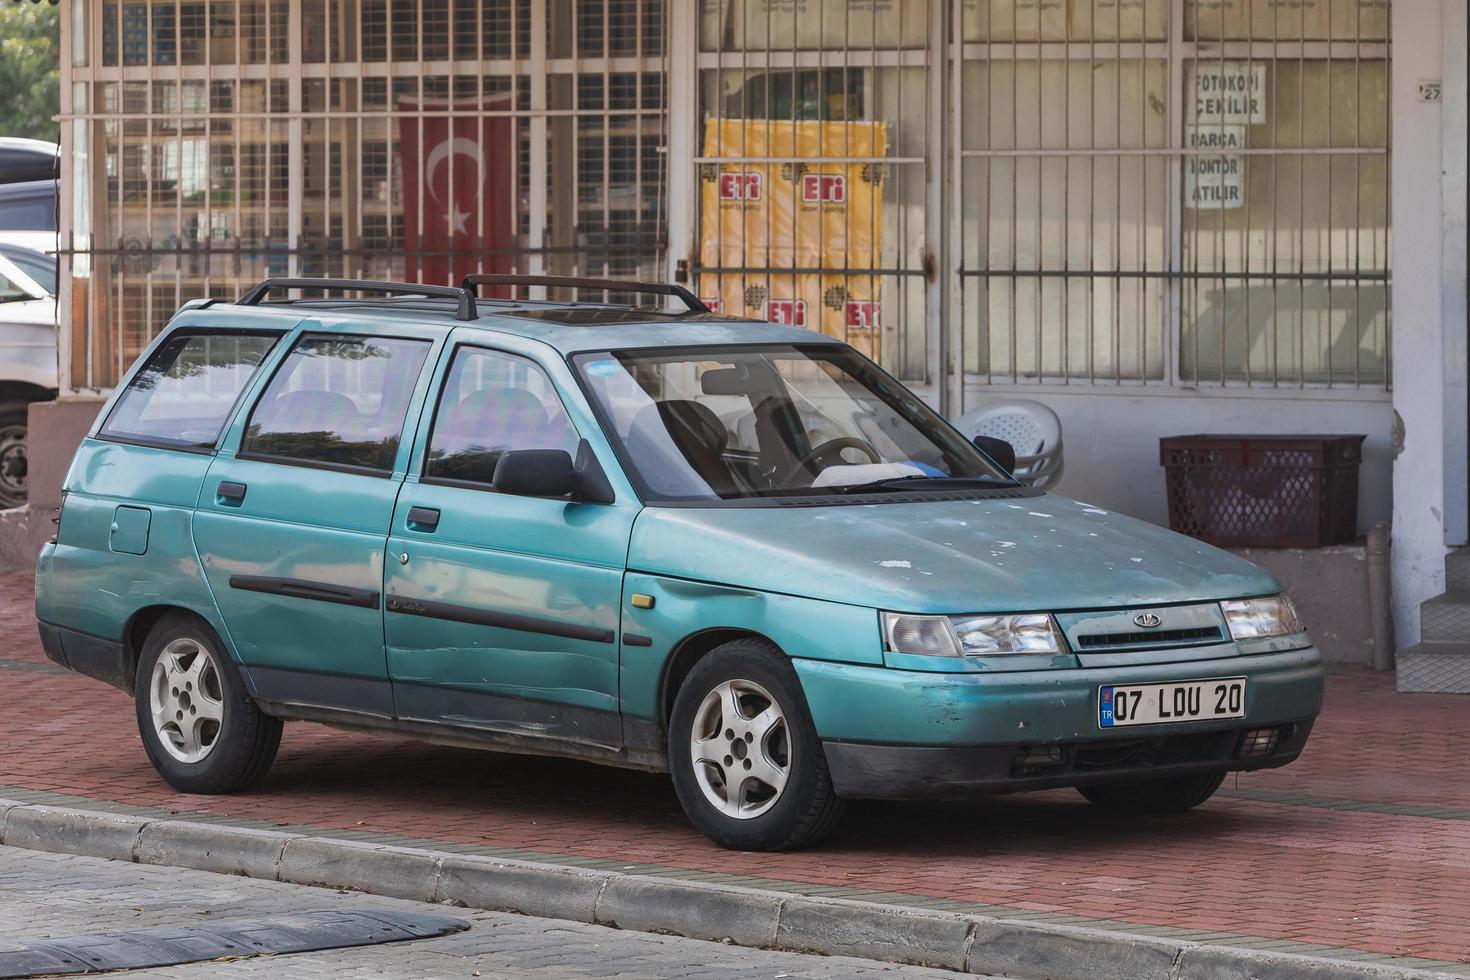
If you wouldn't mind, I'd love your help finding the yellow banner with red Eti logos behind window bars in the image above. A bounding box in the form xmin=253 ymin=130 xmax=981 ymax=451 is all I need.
xmin=698 ymin=119 xmax=888 ymax=354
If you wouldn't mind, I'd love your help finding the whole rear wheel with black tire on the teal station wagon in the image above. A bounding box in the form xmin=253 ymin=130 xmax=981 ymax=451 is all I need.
xmin=132 ymin=613 xmax=282 ymax=793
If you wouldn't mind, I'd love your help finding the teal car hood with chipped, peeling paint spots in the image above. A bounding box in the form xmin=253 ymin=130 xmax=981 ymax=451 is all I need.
xmin=628 ymin=495 xmax=1280 ymax=613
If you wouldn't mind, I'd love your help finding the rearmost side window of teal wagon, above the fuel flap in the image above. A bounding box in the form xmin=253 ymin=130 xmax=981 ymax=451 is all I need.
xmin=98 ymin=334 xmax=279 ymax=450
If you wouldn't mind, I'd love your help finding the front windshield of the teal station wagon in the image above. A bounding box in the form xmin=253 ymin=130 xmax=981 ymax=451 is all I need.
xmin=573 ymin=344 xmax=1014 ymax=501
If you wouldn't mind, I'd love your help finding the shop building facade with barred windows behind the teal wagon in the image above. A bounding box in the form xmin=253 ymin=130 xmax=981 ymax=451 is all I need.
xmin=34 ymin=0 xmax=1470 ymax=652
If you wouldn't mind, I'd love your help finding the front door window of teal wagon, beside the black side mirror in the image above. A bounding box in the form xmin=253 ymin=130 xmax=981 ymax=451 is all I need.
xmin=423 ymin=347 xmax=579 ymax=489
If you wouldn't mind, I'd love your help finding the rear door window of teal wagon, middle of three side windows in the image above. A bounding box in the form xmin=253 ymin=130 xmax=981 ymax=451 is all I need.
xmin=240 ymin=334 xmax=429 ymax=473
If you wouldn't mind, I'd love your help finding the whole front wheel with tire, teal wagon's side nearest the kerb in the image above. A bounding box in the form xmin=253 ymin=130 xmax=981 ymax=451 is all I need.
xmin=669 ymin=638 xmax=842 ymax=851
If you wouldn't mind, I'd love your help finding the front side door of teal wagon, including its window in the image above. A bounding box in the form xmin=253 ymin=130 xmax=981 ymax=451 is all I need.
xmin=384 ymin=342 xmax=638 ymax=746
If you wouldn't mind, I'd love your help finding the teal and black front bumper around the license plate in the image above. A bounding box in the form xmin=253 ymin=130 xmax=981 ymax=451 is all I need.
xmin=795 ymin=648 xmax=1323 ymax=799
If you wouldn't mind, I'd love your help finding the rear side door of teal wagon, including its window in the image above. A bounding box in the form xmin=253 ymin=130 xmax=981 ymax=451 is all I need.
xmin=194 ymin=322 xmax=434 ymax=717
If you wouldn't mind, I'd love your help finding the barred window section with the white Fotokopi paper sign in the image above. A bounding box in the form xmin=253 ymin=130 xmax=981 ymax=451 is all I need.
xmin=951 ymin=0 xmax=1389 ymax=389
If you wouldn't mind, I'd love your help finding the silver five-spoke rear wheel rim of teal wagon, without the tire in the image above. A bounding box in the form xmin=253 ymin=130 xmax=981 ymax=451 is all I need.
xmin=148 ymin=636 xmax=225 ymax=763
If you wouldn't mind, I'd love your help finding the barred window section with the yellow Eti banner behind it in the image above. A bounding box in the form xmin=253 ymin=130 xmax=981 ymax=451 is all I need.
xmin=694 ymin=0 xmax=942 ymax=379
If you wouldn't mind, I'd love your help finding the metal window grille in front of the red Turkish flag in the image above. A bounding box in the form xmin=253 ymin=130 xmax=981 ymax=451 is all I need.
xmin=62 ymin=0 xmax=667 ymax=391
